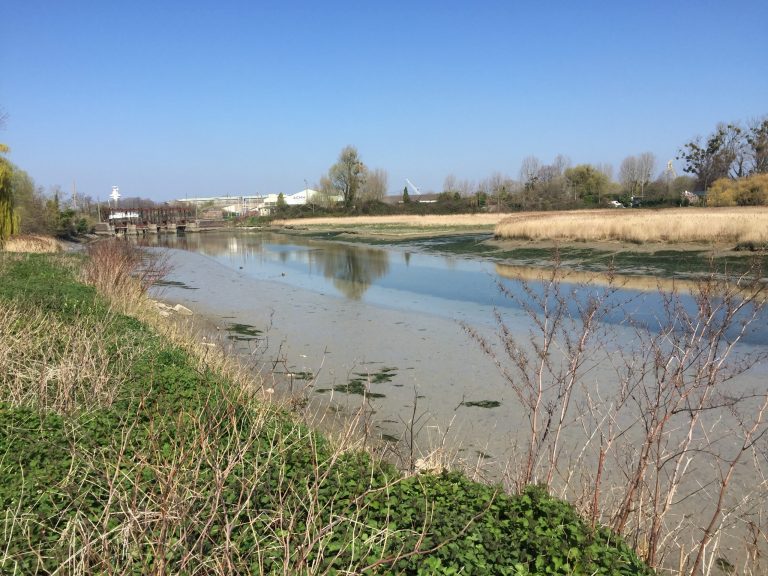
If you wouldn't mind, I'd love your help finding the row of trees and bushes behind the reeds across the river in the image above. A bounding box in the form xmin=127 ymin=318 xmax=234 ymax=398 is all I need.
xmin=304 ymin=117 xmax=768 ymax=213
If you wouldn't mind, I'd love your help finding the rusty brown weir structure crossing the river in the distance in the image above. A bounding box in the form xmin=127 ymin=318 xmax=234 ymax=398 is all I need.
xmin=96 ymin=206 xmax=213 ymax=236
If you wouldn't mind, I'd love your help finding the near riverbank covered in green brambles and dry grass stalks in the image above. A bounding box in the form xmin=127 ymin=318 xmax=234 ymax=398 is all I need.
xmin=0 ymin=242 xmax=651 ymax=575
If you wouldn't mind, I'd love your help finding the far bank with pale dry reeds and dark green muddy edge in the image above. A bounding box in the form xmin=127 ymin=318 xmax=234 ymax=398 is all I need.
xmin=270 ymin=208 xmax=768 ymax=278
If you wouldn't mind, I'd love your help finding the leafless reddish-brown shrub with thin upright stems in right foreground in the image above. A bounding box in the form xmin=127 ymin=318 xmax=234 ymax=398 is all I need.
xmin=465 ymin=254 xmax=768 ymax=574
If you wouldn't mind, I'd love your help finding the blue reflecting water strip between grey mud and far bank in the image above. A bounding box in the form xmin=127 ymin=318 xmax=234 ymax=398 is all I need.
xmin=144 ymin=233 xmax=768 ymax=346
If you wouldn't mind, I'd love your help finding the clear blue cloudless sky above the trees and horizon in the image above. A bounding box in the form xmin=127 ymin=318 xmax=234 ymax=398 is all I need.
xmin=0 ymin=0 xmax=768 ymax=201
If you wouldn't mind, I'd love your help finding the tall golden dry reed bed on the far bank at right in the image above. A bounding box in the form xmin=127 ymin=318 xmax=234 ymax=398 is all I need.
xmin=495 ymin=207 xmax=768 ymax=245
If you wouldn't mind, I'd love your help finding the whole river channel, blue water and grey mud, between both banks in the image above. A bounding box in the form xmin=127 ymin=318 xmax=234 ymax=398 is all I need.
xmin=138 ymin=231 xmax=768 ymax=568
